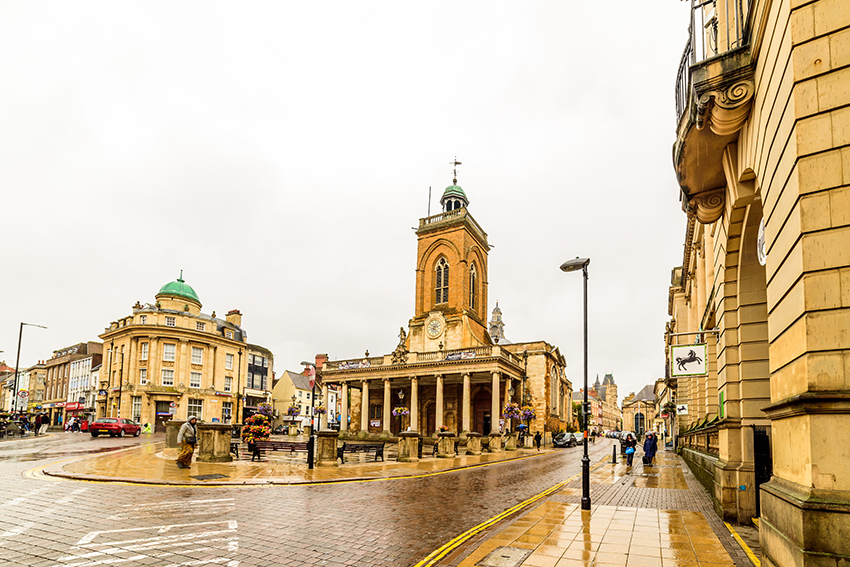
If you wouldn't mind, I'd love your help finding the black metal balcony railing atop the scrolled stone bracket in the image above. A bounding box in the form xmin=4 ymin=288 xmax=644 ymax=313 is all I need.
xmin=676 ymin=0 xmax=751 ymax=123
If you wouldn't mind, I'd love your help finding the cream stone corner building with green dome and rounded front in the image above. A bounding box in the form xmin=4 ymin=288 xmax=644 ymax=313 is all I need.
xmin=97 ymin=272 xmax=274 ymax=431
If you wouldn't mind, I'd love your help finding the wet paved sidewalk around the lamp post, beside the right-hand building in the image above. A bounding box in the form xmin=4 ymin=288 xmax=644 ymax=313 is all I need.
xmin=428 ymin=452 xmax=757 ymax=567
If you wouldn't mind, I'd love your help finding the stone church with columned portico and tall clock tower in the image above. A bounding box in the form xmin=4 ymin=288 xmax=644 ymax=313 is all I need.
xmin=317 ymin=171 xmax=572 ymax=446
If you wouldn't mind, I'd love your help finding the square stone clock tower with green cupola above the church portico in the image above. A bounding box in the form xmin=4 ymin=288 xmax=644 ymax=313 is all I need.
xmin=408 ymin=166 xmax=492 ymax=352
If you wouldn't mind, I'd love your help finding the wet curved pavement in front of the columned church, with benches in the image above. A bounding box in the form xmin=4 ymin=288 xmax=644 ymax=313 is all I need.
xmin=43 ymin=442 xmax=551 ymax=485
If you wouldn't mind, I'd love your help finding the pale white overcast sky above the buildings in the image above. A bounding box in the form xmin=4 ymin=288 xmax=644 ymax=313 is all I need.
xmin=0 ymin=0 xmax=688 ymax=399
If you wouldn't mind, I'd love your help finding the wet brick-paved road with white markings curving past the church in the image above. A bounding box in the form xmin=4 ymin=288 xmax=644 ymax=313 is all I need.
xmin=0 ymin=433 xmax=610 ymax=567
